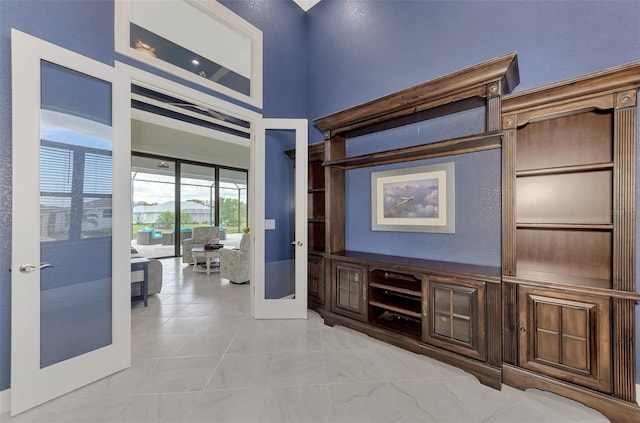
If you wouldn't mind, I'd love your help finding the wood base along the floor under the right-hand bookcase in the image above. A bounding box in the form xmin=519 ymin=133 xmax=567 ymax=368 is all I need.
xmin=502 ymin=364 xmax=640 ymax=423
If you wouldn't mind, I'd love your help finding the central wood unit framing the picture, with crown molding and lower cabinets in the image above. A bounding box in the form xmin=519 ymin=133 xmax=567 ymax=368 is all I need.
xmin=310 ymin=53 xmax=519 ymax=387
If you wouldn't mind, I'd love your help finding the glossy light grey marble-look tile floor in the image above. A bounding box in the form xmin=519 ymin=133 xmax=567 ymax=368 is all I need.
xmin=0 ymin=259 xmax=608 ymax=423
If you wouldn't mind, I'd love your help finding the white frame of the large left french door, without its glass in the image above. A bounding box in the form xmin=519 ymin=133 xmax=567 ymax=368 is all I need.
xmin=11 ymin=29 xmax=131 ymax=415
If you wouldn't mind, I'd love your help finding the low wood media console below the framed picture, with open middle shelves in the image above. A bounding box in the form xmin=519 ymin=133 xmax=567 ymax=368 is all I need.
xmin=323 ymin=251 xmax=502 ymax=388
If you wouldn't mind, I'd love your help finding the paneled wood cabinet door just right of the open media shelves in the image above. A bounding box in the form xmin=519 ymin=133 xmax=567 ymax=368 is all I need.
xmin=422 ymin=275 xmax=487 ymax=360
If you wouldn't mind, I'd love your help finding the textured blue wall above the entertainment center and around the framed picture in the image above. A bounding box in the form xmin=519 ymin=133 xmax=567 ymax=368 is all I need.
xmin=307 ymin=0 xmax=640 ymax=380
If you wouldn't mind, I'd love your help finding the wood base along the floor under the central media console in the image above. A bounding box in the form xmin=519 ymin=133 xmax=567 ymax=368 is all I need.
xmin=321 ymin=311 xmax=502 ymax=390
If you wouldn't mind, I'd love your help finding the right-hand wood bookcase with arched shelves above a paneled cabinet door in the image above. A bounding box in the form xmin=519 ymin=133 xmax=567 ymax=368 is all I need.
xmin=502 ymin=64 xmax=640 ymax=422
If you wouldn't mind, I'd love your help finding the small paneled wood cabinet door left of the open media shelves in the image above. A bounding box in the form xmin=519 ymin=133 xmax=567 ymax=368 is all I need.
xmin=331 ymin=260 xmax=367 ymax=322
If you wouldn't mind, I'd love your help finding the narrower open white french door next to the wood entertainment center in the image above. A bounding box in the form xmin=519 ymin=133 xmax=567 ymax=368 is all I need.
xmin=251 ymin=119 xmax=308 ymax=319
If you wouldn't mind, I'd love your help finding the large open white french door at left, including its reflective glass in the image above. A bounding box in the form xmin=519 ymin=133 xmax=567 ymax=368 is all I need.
xmin=11 ymin=30 xmax=131 ymax=415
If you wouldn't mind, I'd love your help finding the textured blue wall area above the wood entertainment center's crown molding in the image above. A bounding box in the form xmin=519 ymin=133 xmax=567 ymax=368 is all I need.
xmin=307 ymin=0 xmax=640 ymax=136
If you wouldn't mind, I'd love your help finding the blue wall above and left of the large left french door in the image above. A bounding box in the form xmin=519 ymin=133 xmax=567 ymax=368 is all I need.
xmin=0 ymin=0 xmax=115 ymax=390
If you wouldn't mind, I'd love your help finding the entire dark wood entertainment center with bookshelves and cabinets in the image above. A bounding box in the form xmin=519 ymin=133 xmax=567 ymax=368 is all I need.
xmin=308 ymin=53 xmax=640 ymax=422
